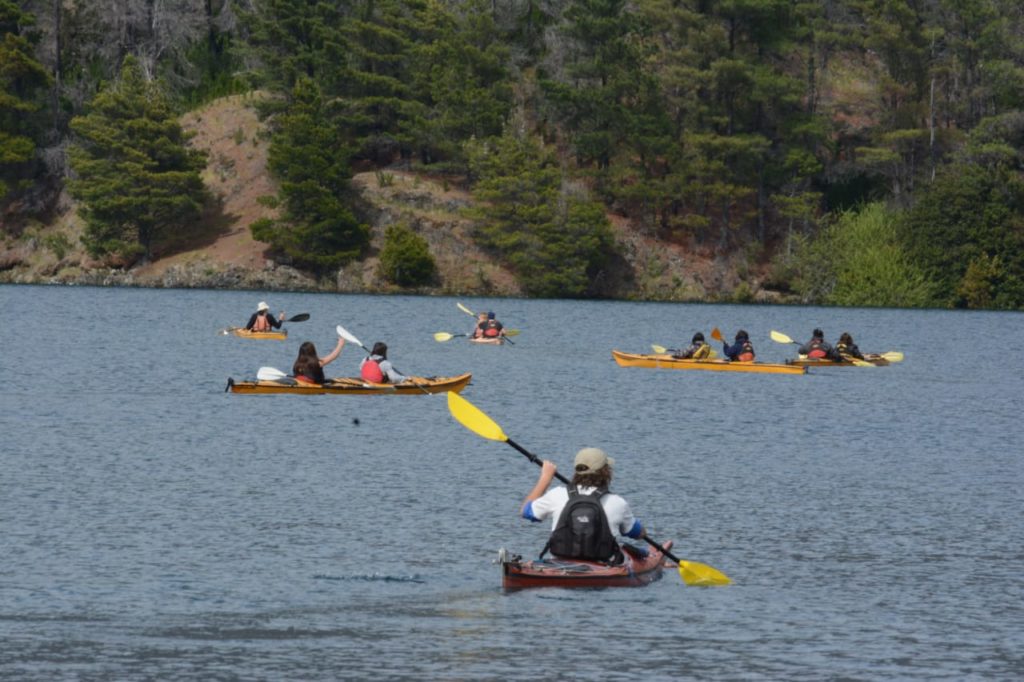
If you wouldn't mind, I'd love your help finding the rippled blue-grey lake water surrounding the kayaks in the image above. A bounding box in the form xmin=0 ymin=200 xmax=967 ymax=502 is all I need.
xmin=0 ymin=286 xmax=1024 ymax=680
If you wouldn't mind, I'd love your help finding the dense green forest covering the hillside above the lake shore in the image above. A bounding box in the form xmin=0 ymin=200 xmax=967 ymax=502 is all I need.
xmin=0 ymin=0 xmax=1024 ymax=309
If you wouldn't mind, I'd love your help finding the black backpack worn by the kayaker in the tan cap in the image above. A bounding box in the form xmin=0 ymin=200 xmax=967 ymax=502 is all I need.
xmin=541 ymin=485 xmax=623 ymax=563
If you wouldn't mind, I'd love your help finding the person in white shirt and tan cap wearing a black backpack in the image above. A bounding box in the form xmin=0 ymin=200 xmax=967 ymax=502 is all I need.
xmin=521 ymin=447 xmax=646 ymax=565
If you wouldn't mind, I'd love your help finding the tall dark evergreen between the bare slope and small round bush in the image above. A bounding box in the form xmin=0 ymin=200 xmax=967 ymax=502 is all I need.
xmin=252 ymin=78 xmax=370 ymax=273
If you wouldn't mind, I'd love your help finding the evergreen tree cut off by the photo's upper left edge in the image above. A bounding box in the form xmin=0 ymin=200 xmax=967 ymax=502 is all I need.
xmin=0 ymin=0 xmax=50 ymax=201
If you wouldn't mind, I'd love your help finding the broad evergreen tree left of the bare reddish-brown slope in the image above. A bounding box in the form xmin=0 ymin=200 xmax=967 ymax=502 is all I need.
xmin=69 ymin=56 xmax=207 ymax=264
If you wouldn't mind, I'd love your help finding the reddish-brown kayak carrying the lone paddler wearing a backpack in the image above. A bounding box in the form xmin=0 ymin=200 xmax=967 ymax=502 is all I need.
xmin=498 ymin=541 xmax=672 ymax=590
